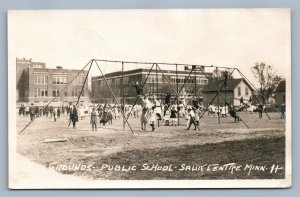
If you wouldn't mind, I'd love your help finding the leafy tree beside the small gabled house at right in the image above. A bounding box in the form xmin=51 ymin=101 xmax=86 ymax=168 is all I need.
xmin=251 ymin=62 xmax=283 ymax=102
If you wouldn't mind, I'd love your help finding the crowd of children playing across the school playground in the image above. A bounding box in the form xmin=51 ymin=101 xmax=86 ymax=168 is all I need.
xmin=19 ymin=83 xmax=285 ymax=131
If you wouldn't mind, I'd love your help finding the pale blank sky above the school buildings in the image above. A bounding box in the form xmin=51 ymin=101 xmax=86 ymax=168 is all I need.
xmin=8 ymin=9 xmax=291 ymax=82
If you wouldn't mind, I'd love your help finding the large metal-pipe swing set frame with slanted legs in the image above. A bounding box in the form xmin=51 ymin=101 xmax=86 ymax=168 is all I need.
xmin=19 ymin=59 xmax=281 ymax=135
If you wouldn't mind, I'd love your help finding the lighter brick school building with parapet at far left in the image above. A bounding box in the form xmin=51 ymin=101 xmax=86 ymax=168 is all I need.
xmin=16 ymin=58 xmax=89 ymax=106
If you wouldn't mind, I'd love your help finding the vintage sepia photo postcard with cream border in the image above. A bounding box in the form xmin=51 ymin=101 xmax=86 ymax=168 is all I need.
xmin=8 ymin=9 xmax=292 ymax=189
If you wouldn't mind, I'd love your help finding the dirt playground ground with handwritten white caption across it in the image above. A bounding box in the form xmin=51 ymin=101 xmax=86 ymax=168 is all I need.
xmin=16 ymin=113 xmax=286 ymax=180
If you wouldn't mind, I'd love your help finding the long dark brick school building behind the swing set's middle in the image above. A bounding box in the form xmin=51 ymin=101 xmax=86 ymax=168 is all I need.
xmin=91 ymin=68 xmax=212 ymax=104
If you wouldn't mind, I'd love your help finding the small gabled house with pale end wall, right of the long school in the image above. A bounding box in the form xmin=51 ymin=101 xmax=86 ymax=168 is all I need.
xmin=202 ymin=78 xmax=253 ymax=106
